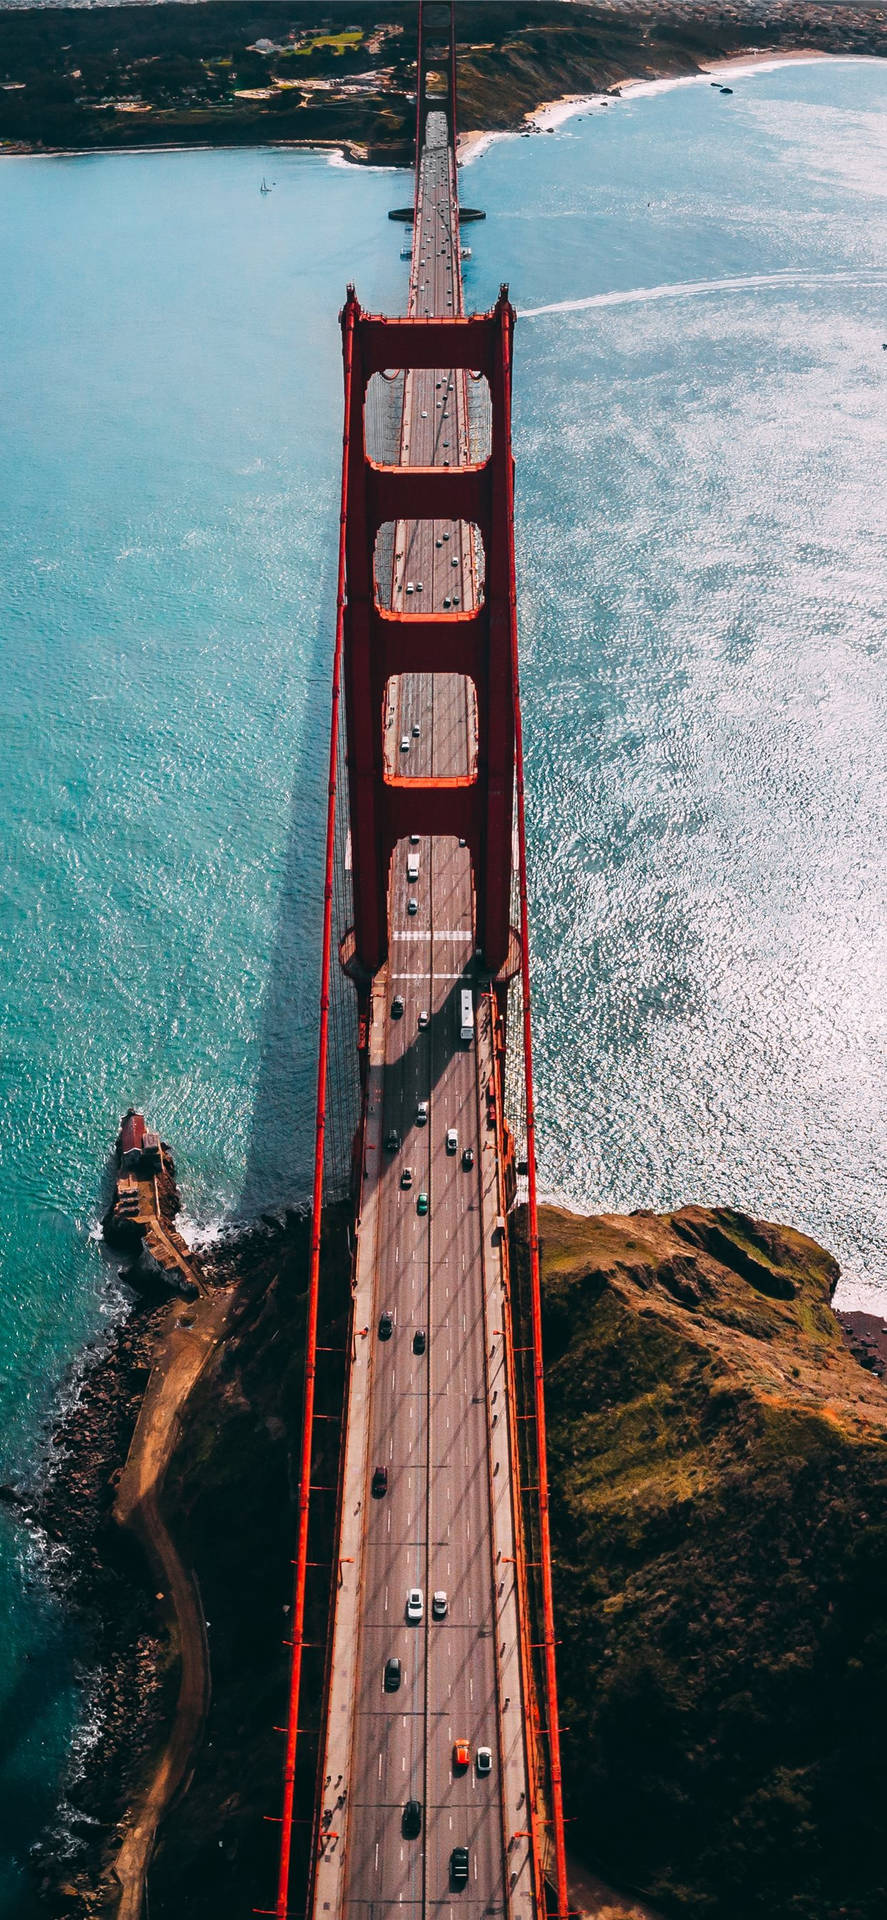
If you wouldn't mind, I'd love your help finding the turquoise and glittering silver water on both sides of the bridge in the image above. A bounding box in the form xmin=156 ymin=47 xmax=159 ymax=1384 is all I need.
xmin=0 ymin=61 xmax=887 ymax=1920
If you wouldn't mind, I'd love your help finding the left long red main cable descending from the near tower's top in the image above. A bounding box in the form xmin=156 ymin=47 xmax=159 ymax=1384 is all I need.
xmin=275 ymin=301 xmax=355 ymax=1920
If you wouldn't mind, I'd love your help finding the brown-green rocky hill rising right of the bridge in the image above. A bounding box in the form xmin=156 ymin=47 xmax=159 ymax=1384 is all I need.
xmin=539 ymin=1208 xmax=887 ymax=1920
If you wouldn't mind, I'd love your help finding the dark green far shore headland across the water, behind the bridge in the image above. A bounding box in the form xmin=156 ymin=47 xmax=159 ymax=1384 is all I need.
xmin=0 ymin=0 xmax=887 ymax=165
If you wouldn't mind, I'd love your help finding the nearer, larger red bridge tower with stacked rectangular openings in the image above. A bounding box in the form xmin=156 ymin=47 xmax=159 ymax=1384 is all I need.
xmin=342 ymin=286 xmax=516 ymax=973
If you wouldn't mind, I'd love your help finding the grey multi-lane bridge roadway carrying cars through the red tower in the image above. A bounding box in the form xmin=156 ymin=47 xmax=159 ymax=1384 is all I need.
xmin=313 ymin=111 xmax=536 ymax=1920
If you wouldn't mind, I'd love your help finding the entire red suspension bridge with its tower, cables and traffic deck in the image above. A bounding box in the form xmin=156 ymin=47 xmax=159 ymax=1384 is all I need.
xmin=270 ymin=4 xmax=568 ymax=1920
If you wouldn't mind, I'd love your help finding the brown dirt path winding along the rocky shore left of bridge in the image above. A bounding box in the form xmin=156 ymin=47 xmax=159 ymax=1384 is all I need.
xmin=109 ymin=1288 xmax=234 ymax=1920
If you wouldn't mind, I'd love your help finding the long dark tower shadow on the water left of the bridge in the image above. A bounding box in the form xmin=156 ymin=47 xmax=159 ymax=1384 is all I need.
xmin=236 ymin=511 xmax=338 ymax=1219
